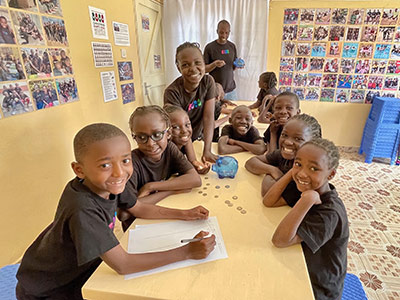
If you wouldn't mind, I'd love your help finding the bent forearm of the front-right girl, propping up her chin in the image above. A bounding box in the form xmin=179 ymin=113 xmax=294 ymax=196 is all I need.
xmin=272 ymin=190 xmax=321 ymax=248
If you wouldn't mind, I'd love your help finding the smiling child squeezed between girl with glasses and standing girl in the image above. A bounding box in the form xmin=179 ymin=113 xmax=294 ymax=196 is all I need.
xmin=164 ymin=105 xmax=211 ymax=174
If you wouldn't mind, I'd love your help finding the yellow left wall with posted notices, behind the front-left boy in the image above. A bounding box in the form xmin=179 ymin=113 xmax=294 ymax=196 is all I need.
xmin=0 ymin=0 xmax=142 ymax=266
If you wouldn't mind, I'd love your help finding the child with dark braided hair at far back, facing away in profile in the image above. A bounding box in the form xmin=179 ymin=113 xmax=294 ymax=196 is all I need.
xmin=249 ymin=72 xmax=279 ymax=113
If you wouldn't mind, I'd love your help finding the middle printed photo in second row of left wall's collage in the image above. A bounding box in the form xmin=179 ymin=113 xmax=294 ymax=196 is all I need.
xmin=11 ymin=10 xmax=45 ymax=45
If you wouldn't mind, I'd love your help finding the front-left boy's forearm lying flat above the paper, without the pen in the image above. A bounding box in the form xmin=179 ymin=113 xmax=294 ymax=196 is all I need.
xmin=127 ymin=201 xmax=208 ymax=220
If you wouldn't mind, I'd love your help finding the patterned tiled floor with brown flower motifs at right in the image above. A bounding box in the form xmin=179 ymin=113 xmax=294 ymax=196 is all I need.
xmin=332 ymin=148 xmax=400 ymax=300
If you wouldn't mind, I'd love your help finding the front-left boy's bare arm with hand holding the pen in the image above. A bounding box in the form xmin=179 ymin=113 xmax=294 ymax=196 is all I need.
xmin=101 ymin=231 xmax=215 ymax=275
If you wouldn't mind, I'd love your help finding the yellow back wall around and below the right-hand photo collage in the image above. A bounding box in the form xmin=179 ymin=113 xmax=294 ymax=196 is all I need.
xmin=267 ymin=0 xmax=400 ymax=147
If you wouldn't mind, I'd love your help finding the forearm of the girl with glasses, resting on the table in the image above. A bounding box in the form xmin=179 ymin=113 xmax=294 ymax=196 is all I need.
xmin=138 ymin=168 xmax=201 ymax=204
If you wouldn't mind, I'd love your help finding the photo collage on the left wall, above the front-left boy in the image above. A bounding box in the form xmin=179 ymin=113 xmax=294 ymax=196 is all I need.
xmin=0 ymin=0 xmax=79 ymax=118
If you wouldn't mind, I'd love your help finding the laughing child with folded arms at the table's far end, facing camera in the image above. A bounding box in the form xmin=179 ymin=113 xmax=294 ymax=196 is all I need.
xmin=218 ymin=105 xmax=266 ymax=154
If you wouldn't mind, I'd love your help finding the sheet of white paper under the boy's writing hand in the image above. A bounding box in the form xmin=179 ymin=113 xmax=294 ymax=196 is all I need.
xmin=125 ymin=217 xmax=228 ymax=279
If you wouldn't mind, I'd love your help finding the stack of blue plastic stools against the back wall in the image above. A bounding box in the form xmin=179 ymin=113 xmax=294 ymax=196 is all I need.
xmin=359 ymin=97 xmax=400 ymax=165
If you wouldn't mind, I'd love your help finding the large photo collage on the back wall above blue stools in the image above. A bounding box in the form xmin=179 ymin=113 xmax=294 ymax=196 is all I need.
xmin=279 ymin=8 xmax=400 ymax=104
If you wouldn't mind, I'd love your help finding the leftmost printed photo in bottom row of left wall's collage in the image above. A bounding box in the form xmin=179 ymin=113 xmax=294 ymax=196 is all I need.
xmin=0 ymin=81 xmax=33 ymax=117
